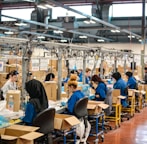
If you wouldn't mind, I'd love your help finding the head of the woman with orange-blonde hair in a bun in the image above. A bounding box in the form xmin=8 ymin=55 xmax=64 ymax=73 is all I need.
xmin=68 ymin=74 xmax=78 ymax=92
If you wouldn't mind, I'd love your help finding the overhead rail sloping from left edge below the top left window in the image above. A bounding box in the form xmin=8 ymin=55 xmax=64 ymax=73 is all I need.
xmin=1 ymin=15 xmax=113 ymax=41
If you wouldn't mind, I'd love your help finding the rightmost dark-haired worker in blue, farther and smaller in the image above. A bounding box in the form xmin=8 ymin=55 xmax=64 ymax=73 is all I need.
xmin=126 ymin=71 xmax=137 ymax=89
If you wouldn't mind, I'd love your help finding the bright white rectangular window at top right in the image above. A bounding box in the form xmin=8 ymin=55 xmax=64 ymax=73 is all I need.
xmin=109 ymin=3 xmax=147 ymax=17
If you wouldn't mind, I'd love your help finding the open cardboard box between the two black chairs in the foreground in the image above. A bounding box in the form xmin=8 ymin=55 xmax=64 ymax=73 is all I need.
xmin=54 ymin=114 xmax=80 ymax=130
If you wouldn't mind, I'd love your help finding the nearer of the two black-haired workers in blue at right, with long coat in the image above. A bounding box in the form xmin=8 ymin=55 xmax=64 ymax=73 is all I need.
xmin=112 ymin=72 xmax=129 ymax=107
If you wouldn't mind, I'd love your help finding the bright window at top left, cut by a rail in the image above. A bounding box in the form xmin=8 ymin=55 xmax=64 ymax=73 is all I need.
xmin=1 ymin=8 xmax=34 ymax=21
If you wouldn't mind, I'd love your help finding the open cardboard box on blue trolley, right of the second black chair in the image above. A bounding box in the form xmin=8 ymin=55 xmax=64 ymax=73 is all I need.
xmin=87 ymin=100 xmax=109 ymax=115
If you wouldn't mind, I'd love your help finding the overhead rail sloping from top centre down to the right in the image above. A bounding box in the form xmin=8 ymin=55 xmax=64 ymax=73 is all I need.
xmin=46 ymin=0 xmax=141 ymax=38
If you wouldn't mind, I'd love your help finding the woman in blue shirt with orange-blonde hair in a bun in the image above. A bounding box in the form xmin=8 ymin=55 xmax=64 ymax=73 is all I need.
xmin=67 ymin=75 xmax=84 ymax=115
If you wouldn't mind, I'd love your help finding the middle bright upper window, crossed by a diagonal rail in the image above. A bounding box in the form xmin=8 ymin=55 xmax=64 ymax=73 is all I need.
xmin=52 ymin=5 xmax=92 ymax=19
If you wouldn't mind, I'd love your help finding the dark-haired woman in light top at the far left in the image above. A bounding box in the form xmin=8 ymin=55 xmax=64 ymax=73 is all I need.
xmin=1 ymin=70 xmax=18 ymax=98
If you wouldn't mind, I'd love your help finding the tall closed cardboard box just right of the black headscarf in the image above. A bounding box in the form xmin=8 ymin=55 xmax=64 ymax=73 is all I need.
xmin=43 ymin=81 xmax=57 ymax=101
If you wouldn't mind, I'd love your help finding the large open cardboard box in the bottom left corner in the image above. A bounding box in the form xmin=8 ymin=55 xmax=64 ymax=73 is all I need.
xmin=0 ymin=125 xmax=43 ymax=144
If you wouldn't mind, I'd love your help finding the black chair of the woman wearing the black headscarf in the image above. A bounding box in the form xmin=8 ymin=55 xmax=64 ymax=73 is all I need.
xmin=32 ymin=108 xmax=55 ymax=144
